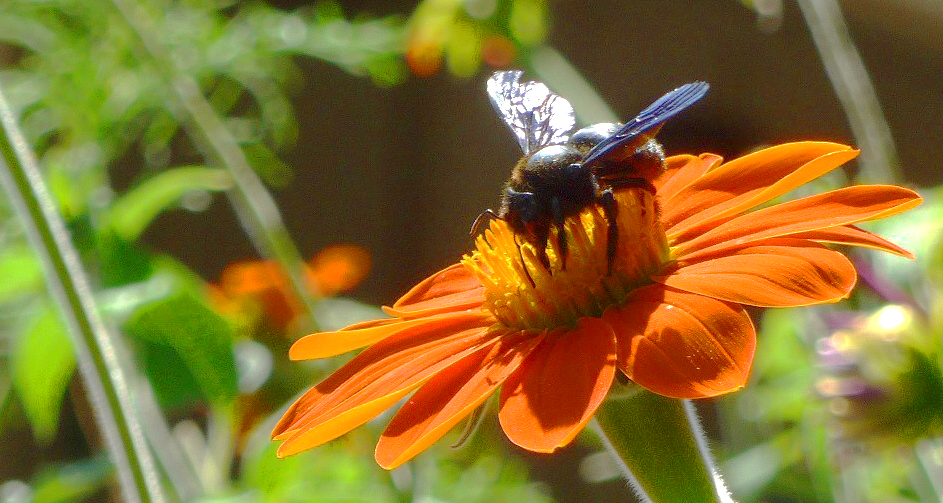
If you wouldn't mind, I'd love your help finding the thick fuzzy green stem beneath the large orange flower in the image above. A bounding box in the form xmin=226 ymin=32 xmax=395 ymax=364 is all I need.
xmin=596 ymin=391 xmax=732 ymax=503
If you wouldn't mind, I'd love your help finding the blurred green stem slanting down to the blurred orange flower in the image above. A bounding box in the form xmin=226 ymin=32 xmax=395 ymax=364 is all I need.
xmin=112 ymin=0 xmax=318 ymax=329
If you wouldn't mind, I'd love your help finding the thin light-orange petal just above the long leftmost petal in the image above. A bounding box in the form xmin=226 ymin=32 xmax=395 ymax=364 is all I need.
xmin=288 ymin=311 xmax=494 ymax=360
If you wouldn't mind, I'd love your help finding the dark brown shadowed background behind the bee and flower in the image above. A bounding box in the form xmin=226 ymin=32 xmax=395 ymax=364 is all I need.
xmin=145 ymin=0 xmax=943 ymax=310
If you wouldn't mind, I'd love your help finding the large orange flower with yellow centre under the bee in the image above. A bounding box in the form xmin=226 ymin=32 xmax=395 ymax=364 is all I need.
xmin=273 ymin=142 xmax=921 ymax=469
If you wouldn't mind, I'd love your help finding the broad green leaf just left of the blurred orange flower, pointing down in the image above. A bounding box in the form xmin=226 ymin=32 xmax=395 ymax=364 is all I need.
xmin=125 ymin=291 xmax=237 ymax=403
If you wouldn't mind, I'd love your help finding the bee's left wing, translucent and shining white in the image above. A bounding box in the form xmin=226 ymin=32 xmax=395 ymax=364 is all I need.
xmin=488 ymin=70 xmax=576 ymax=154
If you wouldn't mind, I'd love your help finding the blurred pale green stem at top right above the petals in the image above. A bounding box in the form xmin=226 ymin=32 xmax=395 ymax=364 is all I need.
xmin=797 ymin=0 xmax=900 ymax=183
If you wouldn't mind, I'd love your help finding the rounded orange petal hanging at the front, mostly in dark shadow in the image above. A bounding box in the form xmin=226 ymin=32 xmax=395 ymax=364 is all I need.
xmin=498 ymin=318 xmax=616 ymax=452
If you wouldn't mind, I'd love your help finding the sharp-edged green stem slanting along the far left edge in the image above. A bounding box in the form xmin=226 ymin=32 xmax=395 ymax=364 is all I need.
xmin=0 ymin=82 xmax=164 ymax=502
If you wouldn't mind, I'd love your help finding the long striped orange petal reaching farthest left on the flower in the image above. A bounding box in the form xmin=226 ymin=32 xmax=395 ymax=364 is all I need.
xmin=272 ymin=314 xmax=501 ymax=448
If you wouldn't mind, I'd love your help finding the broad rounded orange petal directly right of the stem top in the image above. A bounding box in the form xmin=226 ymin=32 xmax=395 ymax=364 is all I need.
xmin=603 ymin=285 xmax=756 ymax=398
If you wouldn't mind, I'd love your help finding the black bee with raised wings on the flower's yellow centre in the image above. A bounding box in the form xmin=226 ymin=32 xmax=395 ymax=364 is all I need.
xmin=471 ymin=70 xmax=709 ymax=283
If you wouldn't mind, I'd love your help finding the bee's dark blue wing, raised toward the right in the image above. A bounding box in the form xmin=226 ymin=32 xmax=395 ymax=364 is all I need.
xmin=583 ymin=82 xmax=710 ymax=164
